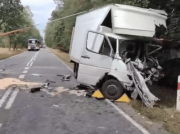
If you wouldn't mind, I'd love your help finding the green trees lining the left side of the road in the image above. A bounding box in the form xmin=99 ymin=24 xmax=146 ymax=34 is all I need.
xmin=0 ymin=0 xmax=42 ymax=50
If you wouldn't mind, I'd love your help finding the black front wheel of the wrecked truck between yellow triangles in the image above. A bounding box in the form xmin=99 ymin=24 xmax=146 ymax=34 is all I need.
xmin=101 ymin=79 xmax=124 ymax=100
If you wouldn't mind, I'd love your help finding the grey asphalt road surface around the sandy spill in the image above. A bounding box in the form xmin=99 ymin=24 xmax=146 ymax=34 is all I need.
xmin=0 ymin=49 xmax=146 ymax=134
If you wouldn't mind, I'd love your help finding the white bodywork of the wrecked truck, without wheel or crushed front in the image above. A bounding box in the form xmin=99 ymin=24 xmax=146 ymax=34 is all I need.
xmin=69 ymin=4 xmax=167 ymax=85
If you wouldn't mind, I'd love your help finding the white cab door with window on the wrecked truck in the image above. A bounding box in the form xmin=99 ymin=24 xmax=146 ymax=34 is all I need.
xmin=77 ymin=32 xmax=113 ymax=85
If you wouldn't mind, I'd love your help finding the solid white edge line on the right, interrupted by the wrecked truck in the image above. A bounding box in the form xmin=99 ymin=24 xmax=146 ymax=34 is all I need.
xmin=53 ymin=49 xmax=150 ymax=134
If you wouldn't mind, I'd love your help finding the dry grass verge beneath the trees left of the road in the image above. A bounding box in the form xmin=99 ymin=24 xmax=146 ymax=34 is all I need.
xmin=0 ymin=48 xmax=26 ymax=60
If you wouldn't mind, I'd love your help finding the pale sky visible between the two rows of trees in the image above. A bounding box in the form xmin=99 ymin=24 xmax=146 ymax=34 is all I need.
xmin=21 ymin=0 xmax=56 ymax=36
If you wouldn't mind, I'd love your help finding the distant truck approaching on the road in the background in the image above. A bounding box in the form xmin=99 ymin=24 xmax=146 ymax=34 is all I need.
xmin=28 ymin=39 xmax=40 ymax=51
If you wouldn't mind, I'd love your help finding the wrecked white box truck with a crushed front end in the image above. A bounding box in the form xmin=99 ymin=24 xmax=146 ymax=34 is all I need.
xmin=70 ymin=4 xmax=167 ymax=106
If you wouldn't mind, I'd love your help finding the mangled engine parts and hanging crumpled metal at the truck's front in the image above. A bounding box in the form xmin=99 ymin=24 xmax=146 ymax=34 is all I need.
xmin=125 ymin=57 xmax=163 ymax=107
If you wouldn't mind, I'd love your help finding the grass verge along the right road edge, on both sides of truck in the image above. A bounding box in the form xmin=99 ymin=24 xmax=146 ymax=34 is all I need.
xmin=50 ymin=49 xmax=180 ymax=134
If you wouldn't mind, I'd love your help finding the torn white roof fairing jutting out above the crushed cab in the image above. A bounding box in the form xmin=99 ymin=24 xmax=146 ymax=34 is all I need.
xmin=112 ymin=4 xmax=167 ymax=37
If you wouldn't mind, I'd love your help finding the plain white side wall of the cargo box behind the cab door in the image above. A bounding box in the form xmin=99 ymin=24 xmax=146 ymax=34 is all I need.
xmin=70 ymin=7 xmax=110 ymax=62
